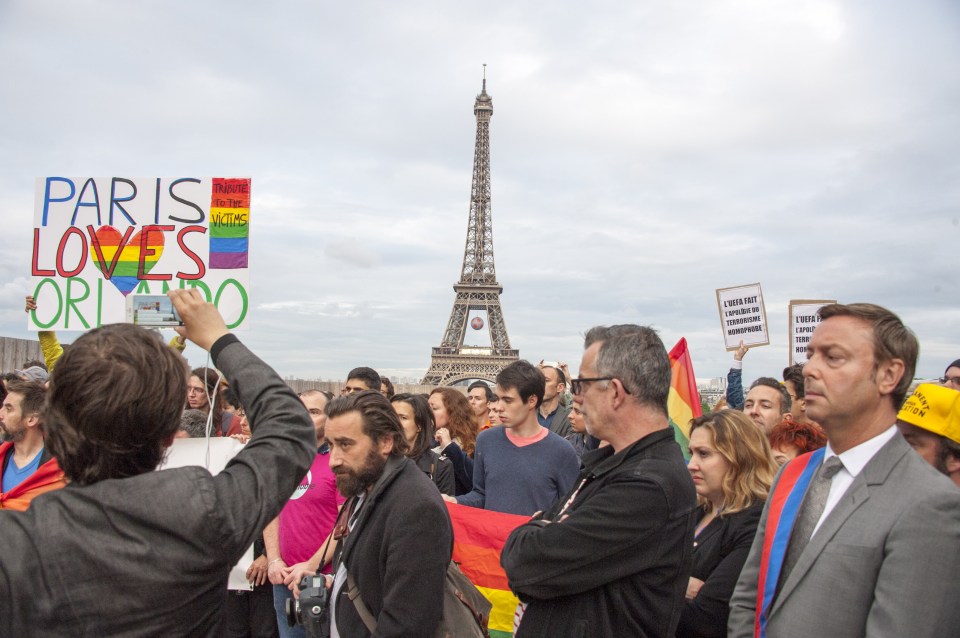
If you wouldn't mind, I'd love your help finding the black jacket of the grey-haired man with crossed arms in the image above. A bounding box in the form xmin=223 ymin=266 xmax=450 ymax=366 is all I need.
xmin=501 ymin=429 xmax=697 ymax=638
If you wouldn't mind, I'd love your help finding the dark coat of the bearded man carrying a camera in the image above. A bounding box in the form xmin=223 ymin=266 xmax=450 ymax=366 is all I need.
xmin=331 ymin=457 xmax=453 ymax=638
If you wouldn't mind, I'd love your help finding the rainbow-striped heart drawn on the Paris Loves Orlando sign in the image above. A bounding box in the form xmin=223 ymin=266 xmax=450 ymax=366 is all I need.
xmin=90 ymin=226 xmax=163 ymax=297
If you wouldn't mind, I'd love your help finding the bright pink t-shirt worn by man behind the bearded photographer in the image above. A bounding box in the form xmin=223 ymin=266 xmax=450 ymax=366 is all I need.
xmin=280 ymin=447 xmax=345 ymax=573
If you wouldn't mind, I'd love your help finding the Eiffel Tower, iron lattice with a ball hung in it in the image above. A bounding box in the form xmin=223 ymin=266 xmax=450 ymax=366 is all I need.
xmin=421 ymin=72 xmax=520 ymax=385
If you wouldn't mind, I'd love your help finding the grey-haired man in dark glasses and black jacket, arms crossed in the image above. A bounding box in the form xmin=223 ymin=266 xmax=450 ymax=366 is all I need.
xmin=501 ymin=325 xmax=697 ymax=638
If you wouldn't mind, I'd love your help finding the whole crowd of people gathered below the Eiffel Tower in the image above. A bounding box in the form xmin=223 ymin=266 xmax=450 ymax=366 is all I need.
xmin=0 ymin=291 xmax=960 ymax=638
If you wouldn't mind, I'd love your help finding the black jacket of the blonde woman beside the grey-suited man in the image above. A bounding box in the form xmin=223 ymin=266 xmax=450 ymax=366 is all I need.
xmin=677 ymin=501 xmax=763 ymax=638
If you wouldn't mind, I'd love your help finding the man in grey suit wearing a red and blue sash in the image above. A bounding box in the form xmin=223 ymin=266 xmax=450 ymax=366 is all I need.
xmin=728 ymin=304 xmax=960 ymax=638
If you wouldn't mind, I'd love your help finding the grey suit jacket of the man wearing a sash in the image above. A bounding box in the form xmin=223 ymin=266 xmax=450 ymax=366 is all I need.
xmin=728 ymin=433 xmax=960 ymax=638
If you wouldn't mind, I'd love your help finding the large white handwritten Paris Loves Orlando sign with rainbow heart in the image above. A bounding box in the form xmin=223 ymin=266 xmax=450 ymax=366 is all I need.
xmin=27 ymin=177 xmax=251 ymax=330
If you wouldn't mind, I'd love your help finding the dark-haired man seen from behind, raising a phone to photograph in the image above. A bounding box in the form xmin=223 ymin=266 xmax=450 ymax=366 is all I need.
xmin=0 ymin=289 xmax=317 ymax=637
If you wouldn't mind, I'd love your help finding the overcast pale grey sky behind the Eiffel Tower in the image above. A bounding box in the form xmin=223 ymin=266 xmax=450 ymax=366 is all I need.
xmin=0 ymin=0 xmax=960 ymax=381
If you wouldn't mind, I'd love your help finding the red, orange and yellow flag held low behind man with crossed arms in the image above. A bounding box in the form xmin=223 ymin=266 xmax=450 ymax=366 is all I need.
xmin=447 ymin=503 xmax=530 ymax=638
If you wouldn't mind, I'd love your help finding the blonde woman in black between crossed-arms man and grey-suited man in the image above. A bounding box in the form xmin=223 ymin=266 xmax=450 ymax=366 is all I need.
xmin=676 ymin=410 xmax=777 ymax=638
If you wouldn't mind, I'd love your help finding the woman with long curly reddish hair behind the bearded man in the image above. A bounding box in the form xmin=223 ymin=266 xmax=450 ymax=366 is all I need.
xmin=427 ymin=388 xmax=477 ymax=496
